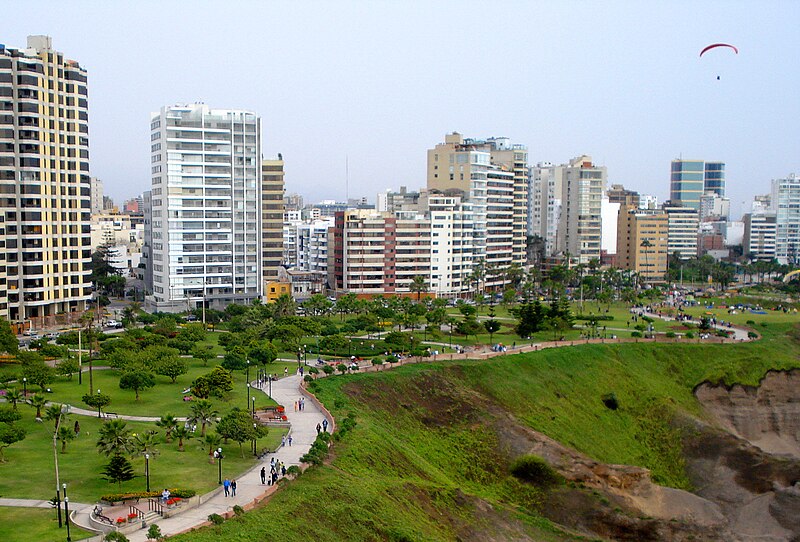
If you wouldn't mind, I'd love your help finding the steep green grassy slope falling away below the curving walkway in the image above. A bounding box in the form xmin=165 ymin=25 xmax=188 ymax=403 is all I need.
xmin=172 ymin=319 xmax=800 ymax=542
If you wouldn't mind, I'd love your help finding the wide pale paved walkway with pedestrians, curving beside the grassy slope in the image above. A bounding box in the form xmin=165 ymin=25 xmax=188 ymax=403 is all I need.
xmin=127 ymin=375 xmax=333 ymax=542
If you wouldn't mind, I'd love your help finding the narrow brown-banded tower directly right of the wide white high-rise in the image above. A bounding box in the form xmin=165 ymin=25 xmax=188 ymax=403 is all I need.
xmin=261 ymin=159 xmax=285 ymax=292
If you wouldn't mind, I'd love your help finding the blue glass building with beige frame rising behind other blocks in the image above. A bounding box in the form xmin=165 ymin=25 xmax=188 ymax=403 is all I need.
xmin=669 ymin=160 xmax=725 ymax=211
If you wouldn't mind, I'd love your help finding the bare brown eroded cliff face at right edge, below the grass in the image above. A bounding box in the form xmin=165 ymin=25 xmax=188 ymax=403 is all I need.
xmin=695 ymin=370 xmax=800 ymax=459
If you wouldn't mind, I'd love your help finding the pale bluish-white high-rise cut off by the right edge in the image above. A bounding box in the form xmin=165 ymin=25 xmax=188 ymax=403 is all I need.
xmin=772 ymin=173 xmax=800 ymax=265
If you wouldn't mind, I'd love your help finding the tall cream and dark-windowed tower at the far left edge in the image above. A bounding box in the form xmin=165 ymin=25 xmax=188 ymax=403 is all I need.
xmin=0 ymin=36 xmax=91 ymax=327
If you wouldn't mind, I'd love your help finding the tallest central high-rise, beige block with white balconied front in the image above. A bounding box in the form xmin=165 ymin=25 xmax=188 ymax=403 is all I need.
xmin=427 ymin=132 xmax=528 ymax=280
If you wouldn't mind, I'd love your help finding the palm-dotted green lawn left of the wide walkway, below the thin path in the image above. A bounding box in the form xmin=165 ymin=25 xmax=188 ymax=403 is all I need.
xmin=0 ymin=412 xmax=284 ymax=503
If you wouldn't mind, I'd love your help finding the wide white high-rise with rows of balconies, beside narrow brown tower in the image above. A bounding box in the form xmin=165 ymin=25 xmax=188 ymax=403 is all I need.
xmin=145 ymin=104 xmax=264 ymax=312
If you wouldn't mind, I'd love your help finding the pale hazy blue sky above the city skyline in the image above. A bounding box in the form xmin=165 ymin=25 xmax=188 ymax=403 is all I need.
xmin=0 ymin=0 xmax=800 ymax=216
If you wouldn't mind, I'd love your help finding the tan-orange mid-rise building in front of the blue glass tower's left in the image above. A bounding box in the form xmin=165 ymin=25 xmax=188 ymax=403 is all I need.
xmin=617 ymin=205 xmax=669 ymax=282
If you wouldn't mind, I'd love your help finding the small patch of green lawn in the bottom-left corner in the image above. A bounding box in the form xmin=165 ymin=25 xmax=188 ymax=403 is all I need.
xmin=0 ymin=507 xmax=94 ymax=542
